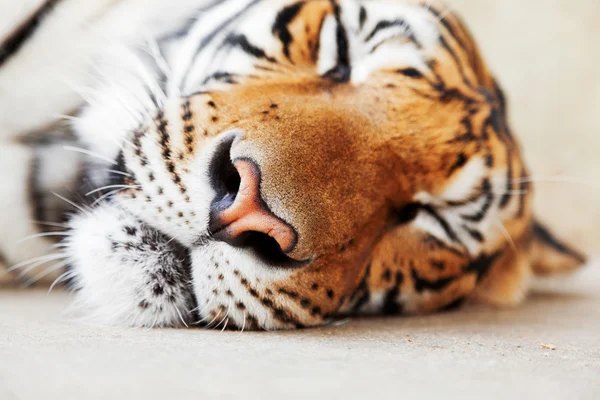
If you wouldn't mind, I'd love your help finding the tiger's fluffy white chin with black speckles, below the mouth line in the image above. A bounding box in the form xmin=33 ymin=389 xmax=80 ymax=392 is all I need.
xmin=64 ymin=204 xmax=194 ymax=327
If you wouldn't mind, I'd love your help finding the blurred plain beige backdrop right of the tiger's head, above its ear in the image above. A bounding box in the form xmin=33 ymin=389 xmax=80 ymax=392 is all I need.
xmin=446 ymin=0 xmax=600 ymax=250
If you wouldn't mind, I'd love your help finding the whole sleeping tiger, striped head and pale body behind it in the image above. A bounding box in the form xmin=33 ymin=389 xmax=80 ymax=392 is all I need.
xmin=0 ymin=0 xmax=585 ymax=330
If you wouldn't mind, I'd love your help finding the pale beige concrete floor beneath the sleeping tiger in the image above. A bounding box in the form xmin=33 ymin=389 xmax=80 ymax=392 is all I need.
xmin=0 ymin=263 xmax=600 ymax=400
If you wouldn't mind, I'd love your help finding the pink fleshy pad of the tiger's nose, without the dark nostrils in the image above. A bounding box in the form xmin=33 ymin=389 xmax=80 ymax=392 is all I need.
xmin=215 ymin=159 xmax=297 ymax=253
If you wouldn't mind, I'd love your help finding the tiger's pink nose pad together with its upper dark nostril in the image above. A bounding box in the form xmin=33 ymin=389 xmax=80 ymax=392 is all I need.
xmin=209 ymin=146 xmax=297 ymax=253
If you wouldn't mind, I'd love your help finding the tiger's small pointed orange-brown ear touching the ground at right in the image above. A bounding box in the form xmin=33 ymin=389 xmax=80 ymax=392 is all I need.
xmin=530 ymin=220 xmax=586 ymax=276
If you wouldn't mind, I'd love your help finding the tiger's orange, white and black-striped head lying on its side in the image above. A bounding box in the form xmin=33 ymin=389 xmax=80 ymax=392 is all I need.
xmin=65 ymin=0 xmax=583 ymax=329
